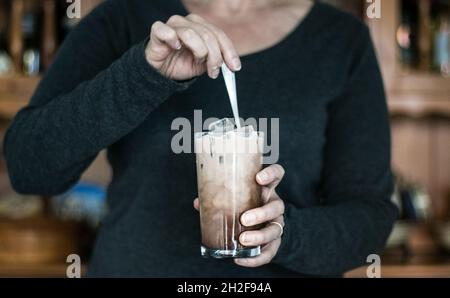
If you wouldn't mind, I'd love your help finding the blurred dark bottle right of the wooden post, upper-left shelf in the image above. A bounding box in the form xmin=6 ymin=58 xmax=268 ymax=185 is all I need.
xmin=22 ymin=0 xmax=41 ymax=76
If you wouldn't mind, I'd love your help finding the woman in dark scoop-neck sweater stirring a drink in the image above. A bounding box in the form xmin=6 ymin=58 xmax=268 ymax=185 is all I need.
xmin=5 ymin=0 xmax=396 ymax=277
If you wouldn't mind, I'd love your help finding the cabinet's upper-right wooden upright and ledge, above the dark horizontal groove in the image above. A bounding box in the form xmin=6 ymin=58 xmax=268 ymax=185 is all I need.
xmin=366 ymin=0 xmax=450 ymax=117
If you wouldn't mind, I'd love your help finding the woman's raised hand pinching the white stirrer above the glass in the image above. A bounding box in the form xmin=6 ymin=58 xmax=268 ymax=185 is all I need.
xmin=145 ymin=14 xmax=241 ymax=81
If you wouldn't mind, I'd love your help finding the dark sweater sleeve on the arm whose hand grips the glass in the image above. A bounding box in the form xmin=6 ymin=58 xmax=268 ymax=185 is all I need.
xmin=273 ymin=26 xmax=397 ymax=275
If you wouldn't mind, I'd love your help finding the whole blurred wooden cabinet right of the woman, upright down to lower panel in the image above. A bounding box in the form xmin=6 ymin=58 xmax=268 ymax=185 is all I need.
xmin=366 ymin=0 xmax=450 ymax=219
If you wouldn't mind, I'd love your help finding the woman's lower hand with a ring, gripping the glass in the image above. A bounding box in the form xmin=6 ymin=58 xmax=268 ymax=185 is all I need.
xmin=194 ymin=165 xmax=284 ymax=267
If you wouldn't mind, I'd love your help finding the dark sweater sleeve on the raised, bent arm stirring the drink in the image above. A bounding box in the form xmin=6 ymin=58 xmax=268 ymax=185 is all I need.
xmin=4 ymin=0 xmax=188 ymax=195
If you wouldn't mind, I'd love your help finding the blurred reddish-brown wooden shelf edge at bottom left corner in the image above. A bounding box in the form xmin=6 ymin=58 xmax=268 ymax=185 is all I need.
xmin=0 ymin=264 xmax=86 ymax=278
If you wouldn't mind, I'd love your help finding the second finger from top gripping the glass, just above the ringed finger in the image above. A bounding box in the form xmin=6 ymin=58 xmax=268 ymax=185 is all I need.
xmin=241 ymin=199 xmax=284 ymax=227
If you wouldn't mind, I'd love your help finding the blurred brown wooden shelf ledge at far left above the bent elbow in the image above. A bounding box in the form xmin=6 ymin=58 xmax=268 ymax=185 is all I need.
xmin=0 ymin=76 xmax=41 ymax=119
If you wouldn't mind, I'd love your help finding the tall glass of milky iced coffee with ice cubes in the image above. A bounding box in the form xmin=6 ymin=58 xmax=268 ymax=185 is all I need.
xmin=195 ymin=119 xmax=264 ymax=258
